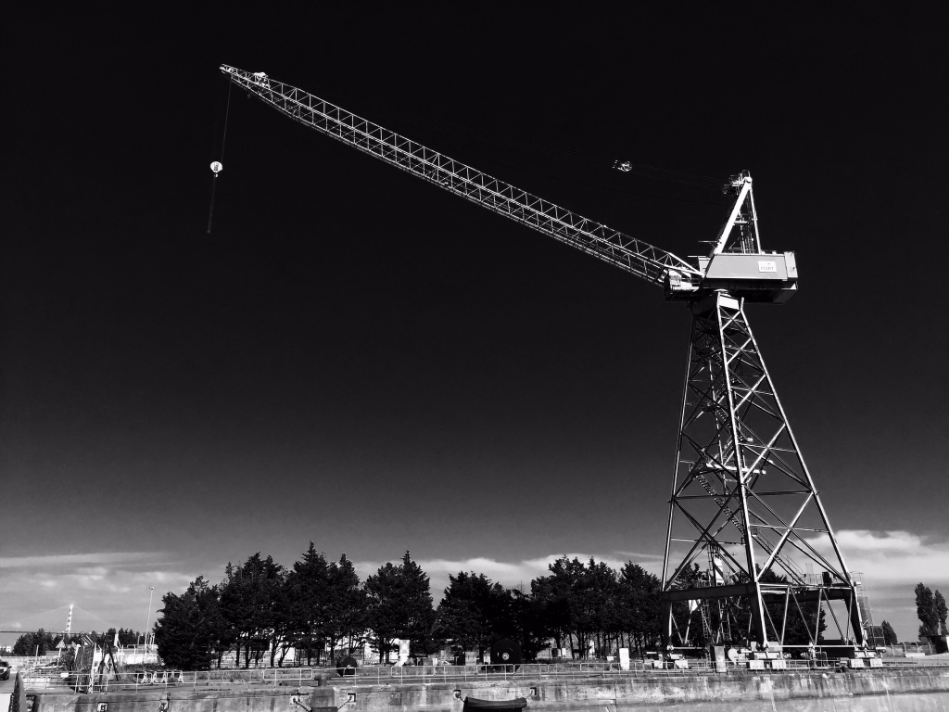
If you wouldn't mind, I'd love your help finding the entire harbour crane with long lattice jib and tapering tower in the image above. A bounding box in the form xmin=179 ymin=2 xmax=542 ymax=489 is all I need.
xmin=220 ymin=65 xmax=866 ymax=658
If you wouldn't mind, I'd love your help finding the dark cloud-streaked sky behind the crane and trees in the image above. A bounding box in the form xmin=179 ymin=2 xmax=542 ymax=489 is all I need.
xmin=0 ymin=3 xmax=949 ymax=637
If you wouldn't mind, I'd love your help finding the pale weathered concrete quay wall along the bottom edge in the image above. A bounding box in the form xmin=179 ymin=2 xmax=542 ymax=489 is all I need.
xmin=30 ymin=668 xmax=949 ymax=712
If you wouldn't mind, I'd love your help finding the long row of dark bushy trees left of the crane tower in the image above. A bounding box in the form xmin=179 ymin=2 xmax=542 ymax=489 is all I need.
xmin=155 ymin=542 xmax=660 ymax=670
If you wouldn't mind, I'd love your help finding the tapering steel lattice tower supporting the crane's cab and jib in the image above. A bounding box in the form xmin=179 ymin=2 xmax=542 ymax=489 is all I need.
xmin=662 ymin=291 xmax=863 ymax=650
